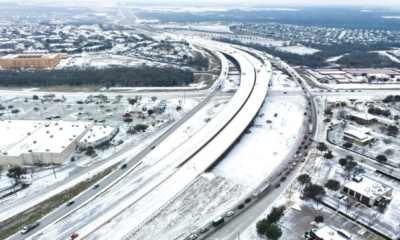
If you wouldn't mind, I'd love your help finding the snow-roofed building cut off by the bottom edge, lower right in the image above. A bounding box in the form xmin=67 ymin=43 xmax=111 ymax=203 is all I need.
xmin=310 ymin=224 xmax=352 ymax=240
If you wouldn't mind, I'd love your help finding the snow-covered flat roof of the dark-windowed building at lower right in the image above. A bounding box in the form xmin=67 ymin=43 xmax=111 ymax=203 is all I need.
xmin=344 ymin=175 xmax=392 ymax=199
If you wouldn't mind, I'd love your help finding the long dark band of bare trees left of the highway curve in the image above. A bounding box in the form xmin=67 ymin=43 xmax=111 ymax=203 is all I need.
xmin=0 ymin=66 xmax=194 ymax=87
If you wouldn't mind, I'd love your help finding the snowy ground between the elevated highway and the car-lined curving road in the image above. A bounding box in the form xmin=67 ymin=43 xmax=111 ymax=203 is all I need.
xmin=120 ymin=97 xmax=304 ymax=239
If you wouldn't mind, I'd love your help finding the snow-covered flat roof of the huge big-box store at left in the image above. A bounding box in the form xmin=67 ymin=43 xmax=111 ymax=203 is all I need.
xmin=0 ymin=120 xmax=92 ymax=156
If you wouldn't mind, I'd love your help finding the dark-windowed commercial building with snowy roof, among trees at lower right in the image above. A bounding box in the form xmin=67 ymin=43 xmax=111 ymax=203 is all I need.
xmin=340 ymin=175 xmax=393 ymax=207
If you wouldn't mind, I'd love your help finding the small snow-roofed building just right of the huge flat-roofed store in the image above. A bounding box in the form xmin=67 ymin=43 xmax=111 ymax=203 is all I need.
xmin=78 ymin=125 xmax=119 ymax=149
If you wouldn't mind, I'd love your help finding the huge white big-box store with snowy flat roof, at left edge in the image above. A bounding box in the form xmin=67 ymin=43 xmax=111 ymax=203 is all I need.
xmin=0 ymin=120 xmax=94 ymax=165
